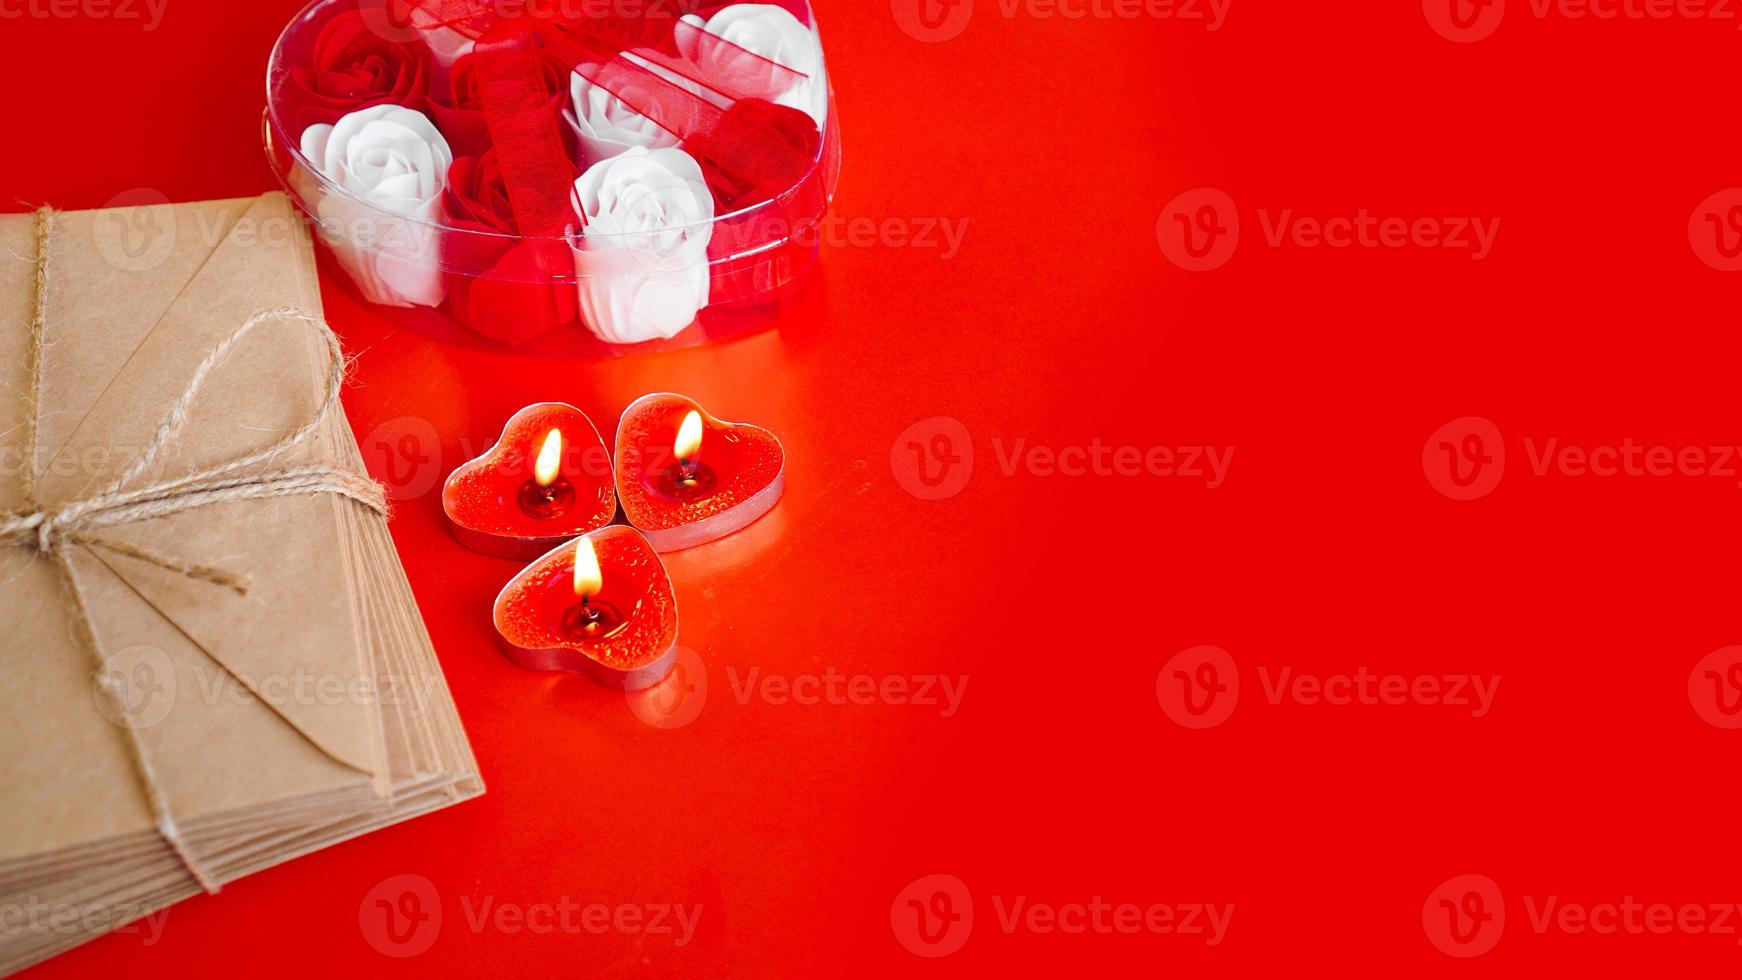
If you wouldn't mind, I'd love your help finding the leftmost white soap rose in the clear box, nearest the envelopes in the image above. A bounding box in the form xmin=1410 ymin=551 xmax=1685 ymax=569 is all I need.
xmin=301 ymin=104 xmax=453 ymax=306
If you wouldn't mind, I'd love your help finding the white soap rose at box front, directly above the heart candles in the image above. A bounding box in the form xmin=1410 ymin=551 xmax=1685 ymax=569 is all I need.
xmin=573 ymin=146 xmax=714 ymax=343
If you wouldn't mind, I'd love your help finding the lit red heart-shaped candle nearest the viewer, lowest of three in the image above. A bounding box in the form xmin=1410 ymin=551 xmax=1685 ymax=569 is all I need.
xmin=495 ymin=524 xmax=678 ymax=691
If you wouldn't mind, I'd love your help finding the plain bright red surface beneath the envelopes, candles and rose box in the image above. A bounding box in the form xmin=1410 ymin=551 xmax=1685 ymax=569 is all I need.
xmin=0 ymin=0 xmax=1742 ymax=980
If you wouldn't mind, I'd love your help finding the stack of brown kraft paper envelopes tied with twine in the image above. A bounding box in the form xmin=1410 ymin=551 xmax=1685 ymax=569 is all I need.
xmin=0 ymin=193 xmax=483 ymax=975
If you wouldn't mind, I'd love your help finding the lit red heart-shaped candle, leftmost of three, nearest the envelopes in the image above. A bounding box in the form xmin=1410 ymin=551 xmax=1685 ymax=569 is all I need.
xmin=441 ymin=402 xmax=617 ymax=559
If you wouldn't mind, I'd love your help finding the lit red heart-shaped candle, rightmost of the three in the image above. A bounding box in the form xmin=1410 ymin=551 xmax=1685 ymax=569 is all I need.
xmin=617 ymin=393 xmax=786 ymax=552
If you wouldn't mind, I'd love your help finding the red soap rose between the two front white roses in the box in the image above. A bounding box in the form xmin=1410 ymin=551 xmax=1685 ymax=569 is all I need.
xmin=442 ymin=150 xmax=577 ymax=345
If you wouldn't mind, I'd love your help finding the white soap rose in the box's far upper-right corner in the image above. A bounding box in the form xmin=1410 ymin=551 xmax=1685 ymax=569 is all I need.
xmin=679 ymin=3 xmax=829 ymax=129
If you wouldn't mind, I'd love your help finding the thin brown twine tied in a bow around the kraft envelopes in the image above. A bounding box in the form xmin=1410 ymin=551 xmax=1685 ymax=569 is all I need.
xmin=0 ymin=207 xmax=387 ymax=891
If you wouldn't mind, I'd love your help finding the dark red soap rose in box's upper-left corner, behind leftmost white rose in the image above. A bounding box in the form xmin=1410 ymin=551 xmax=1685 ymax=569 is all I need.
xmin=279 ymin=10 xmax=430 ymax=136
